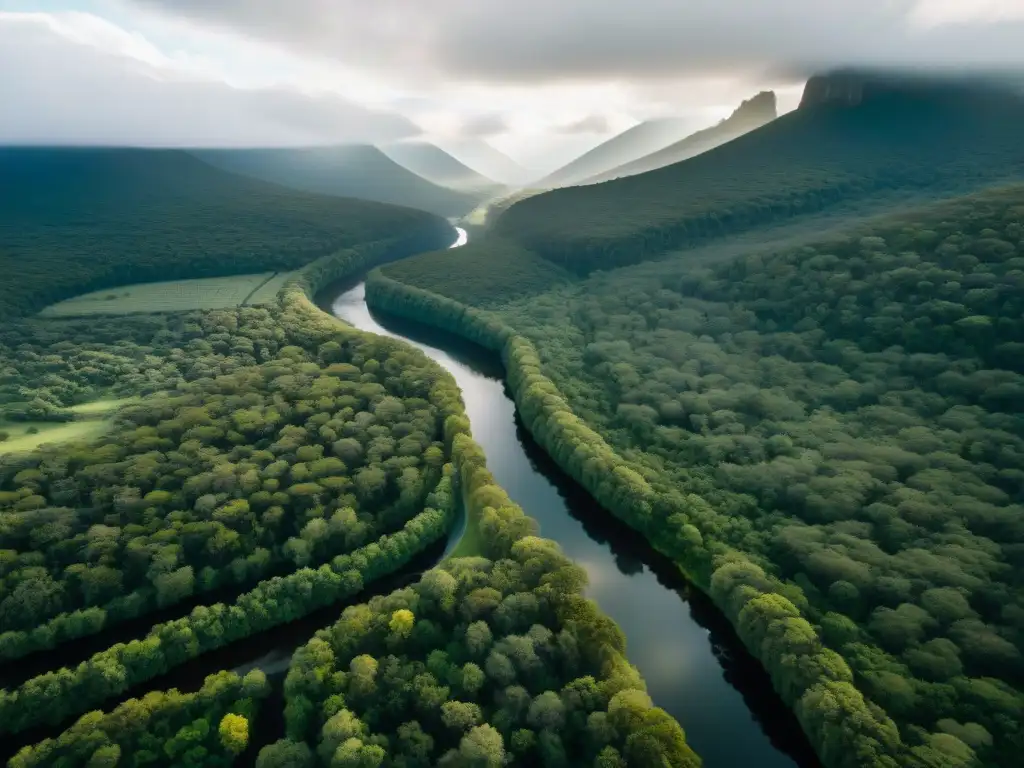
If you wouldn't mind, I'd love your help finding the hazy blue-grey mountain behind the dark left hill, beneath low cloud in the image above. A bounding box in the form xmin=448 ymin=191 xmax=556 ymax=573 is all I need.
xmin=194 ymin=144 xmax=481 ymax=216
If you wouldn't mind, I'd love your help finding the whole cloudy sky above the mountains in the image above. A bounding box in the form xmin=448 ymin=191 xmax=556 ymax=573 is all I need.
xmin=0 ymin=0 xmax=1024 ymax=173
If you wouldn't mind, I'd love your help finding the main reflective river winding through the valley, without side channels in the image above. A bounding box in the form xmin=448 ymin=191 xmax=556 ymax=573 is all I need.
xmin=321 ymin=227 xmax=819 ymax=768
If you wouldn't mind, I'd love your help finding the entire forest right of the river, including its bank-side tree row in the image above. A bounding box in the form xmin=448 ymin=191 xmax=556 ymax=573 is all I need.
xmin=368 ymin=186 xmax=1024 ymax=768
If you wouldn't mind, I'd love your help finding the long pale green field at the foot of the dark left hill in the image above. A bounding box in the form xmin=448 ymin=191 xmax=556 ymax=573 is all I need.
xmin=39 ymin=272 xmax=292 ymax=317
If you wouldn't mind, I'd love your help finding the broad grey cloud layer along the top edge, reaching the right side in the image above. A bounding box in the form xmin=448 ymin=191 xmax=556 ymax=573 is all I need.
xmin=132 ymin=0 xmax=1024 ymax=83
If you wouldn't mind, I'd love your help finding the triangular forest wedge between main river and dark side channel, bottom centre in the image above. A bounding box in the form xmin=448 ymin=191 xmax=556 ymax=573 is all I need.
xmin=274 ymin=434 xmax=700 ymax=768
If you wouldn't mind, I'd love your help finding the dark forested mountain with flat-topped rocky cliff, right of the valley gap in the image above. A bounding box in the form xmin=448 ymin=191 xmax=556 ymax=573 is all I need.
xmin=489 ymin=74 xmax=1024 ymax=273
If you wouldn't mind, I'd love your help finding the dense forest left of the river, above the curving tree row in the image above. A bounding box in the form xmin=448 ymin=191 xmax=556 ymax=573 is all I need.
xmin=0 ymin=308 xmax=444 ymax=657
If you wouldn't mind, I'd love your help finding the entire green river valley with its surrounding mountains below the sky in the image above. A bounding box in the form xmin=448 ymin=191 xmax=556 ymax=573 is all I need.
xmin=0 ymin=43 xmax=1024 ymax=768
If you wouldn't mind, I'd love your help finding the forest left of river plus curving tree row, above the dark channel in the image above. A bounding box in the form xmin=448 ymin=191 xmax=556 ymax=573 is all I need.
xmin=0 ymin=246 xmax=473 ymax=732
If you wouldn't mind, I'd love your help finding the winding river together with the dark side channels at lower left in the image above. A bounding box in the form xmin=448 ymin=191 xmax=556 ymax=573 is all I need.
xmin=0 ymin=228 xmax=819 ymax=768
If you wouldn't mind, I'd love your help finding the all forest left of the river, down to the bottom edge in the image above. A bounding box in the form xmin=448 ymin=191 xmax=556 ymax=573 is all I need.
xmin=0 ymin=153 xmax=699 ymax=768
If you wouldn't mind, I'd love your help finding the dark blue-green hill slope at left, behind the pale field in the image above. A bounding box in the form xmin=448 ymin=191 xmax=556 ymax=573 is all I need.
xmin=0 ymin=148 xmax=451 ymax=317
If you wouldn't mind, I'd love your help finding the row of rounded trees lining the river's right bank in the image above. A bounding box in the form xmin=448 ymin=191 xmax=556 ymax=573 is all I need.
xmin=367 ymin=270 xmax=904 ymax=768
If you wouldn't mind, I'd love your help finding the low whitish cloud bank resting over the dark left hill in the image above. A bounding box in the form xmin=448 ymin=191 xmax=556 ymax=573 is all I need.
xmin=0 ymin=12 xmax=419 ymax=145
